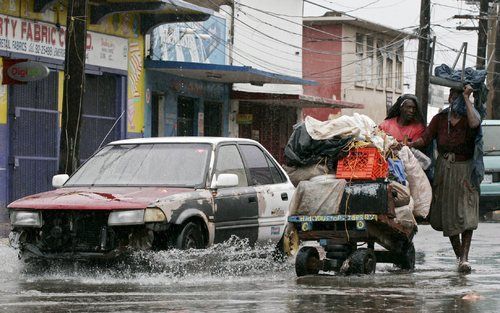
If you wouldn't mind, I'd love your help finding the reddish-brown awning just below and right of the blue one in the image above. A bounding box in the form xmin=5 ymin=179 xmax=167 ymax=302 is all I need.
xmin=231 ymin=90 xmax=365 ymax=109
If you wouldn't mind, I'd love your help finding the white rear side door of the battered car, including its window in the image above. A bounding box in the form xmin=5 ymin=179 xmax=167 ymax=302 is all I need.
xmin=239 ymin=143 xmax=295 ymax=241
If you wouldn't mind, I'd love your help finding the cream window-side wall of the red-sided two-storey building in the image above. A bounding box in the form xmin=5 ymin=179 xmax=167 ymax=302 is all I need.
xmin=341 ymin=25 xmax=402 ymax=124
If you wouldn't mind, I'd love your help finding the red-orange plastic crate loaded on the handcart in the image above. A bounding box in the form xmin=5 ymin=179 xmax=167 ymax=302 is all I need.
xmin=336 ymin=148 xmax=389 ymax=180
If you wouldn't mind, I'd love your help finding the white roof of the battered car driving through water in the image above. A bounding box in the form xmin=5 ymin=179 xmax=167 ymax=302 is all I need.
xmin=109 ymin=137 xmax=257 ymax=145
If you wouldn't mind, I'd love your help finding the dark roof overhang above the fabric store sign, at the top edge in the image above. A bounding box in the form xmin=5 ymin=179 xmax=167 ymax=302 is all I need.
xmin=34 ymin=0 xmax=214 ymax=34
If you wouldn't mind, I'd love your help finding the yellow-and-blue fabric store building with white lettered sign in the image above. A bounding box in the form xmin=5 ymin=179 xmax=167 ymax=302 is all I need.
xmin=0 ymin=0 xmax=212 ymax=222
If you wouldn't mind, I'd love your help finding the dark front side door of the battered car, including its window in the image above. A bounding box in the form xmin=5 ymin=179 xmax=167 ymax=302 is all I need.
xmin=214 ymin=144 xmax=259 ymax=243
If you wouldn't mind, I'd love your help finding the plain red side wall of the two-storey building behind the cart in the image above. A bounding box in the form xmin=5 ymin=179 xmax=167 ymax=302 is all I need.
xmin=302 ymin=24 xmax=342 ymax=121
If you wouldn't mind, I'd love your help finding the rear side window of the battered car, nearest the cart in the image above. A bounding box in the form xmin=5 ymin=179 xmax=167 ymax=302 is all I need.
xmin=240 ymin=145 xmax=274 ymax=185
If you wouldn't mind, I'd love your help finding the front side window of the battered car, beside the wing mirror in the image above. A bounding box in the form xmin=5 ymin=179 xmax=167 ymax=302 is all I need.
xmin=215 ymin=145 xmax=248 ymax=187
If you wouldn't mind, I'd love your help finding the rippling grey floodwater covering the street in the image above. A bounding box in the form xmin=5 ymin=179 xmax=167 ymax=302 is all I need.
xmin=0 ymin=223 xmax=500 ymax=313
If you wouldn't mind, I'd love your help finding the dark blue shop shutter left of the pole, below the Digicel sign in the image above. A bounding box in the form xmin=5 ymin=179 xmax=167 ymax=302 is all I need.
xmin=8 ymin=71 xmax=59 ymax=202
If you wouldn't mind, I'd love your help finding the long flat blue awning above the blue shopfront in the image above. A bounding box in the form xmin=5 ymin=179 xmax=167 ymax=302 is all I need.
xmin=144 ymin=59 xmax=318 ymax=86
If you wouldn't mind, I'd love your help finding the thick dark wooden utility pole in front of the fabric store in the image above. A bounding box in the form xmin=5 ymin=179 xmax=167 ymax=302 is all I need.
xmin=59 ymin=0 xmax=88 ymax=175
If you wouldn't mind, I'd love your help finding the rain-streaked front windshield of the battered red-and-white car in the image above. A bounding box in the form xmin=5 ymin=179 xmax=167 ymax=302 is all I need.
xmin=65 ymin=143 xmax=211 ymax=187
